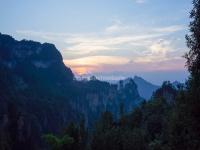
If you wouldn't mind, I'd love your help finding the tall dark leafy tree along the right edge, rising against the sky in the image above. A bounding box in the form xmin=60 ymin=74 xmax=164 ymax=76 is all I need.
xmin=170 ymin=0 xmax=200 ymax=150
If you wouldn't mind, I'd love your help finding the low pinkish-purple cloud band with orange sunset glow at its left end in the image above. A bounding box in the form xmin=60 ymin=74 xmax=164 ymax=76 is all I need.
xmin=66 ymin=58 xmax=185 ymax=75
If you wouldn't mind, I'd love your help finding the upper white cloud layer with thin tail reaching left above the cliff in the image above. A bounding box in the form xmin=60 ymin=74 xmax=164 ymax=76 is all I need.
xmin=17 ymin=22 xmax=183 ymax=57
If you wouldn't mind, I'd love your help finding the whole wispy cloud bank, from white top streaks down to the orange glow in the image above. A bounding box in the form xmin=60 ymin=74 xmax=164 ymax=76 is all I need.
xmin=17 ymin=20 xmax=185 ymax=74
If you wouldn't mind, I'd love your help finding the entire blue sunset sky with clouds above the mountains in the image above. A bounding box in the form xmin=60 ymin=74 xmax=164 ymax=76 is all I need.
xmin=0 ymin=0 xmax=192 ymax=84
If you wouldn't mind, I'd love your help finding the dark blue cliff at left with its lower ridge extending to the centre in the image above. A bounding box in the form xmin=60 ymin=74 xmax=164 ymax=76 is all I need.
xmin=0 ymin=34 xmax=142 ymax=150
